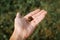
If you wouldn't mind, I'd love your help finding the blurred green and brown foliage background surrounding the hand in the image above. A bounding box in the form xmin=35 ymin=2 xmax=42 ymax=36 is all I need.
xmin=0 ymin=0 xmax=60 ymax=40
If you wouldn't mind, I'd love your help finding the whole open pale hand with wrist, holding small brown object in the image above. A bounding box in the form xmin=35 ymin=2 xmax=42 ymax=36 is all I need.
xmin=10 ymin=9 xmax=47 ymax=40
